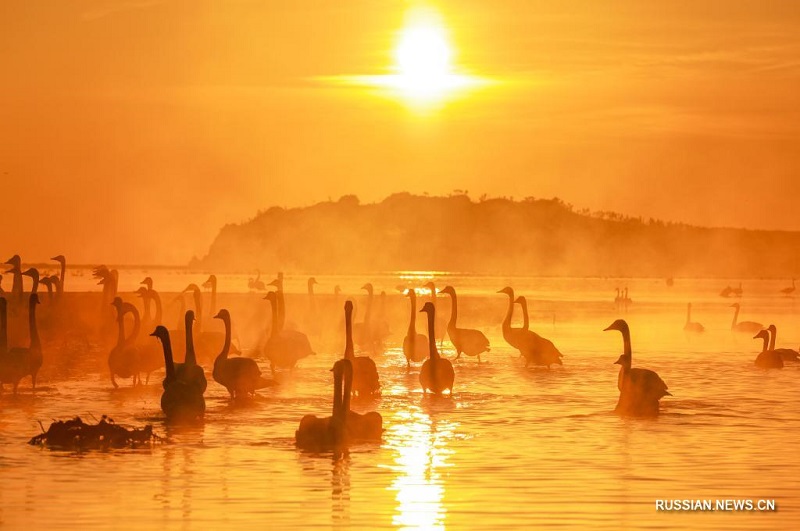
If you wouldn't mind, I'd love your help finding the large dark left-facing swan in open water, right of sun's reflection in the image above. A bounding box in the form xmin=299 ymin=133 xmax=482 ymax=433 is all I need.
xmin=605 ymin=319 xmax=672 ymax=416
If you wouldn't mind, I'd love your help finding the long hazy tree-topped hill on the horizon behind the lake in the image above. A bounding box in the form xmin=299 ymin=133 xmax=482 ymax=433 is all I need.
xmin=192 ymin=193 xmax=800 ymax=278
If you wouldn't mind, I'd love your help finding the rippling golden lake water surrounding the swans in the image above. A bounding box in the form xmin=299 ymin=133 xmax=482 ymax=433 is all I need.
xmin=0 ymin=276 xmax=800 ymax=529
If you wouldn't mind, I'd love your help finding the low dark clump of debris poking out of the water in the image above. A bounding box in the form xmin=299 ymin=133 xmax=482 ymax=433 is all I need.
xmin=28 ymin=415 xmax=157 ymax=451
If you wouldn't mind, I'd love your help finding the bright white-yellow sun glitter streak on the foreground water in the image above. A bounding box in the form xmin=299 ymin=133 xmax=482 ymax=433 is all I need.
xmin=386 ymin=409 xmax=457 ymax=529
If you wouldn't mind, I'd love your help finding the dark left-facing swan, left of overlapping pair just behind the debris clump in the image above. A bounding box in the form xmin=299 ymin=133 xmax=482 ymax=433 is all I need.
xmin=150 ymin=325 xmax=206 ymax=422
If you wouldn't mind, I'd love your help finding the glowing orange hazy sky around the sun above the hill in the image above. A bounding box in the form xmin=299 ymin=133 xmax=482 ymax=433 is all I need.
xmin=0 ymin=0 xmax=800 ymax=263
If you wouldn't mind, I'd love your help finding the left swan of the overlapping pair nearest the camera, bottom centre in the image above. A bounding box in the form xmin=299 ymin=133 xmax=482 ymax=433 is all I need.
xmin=294 ymin=359 xmax=353 ymax=450
